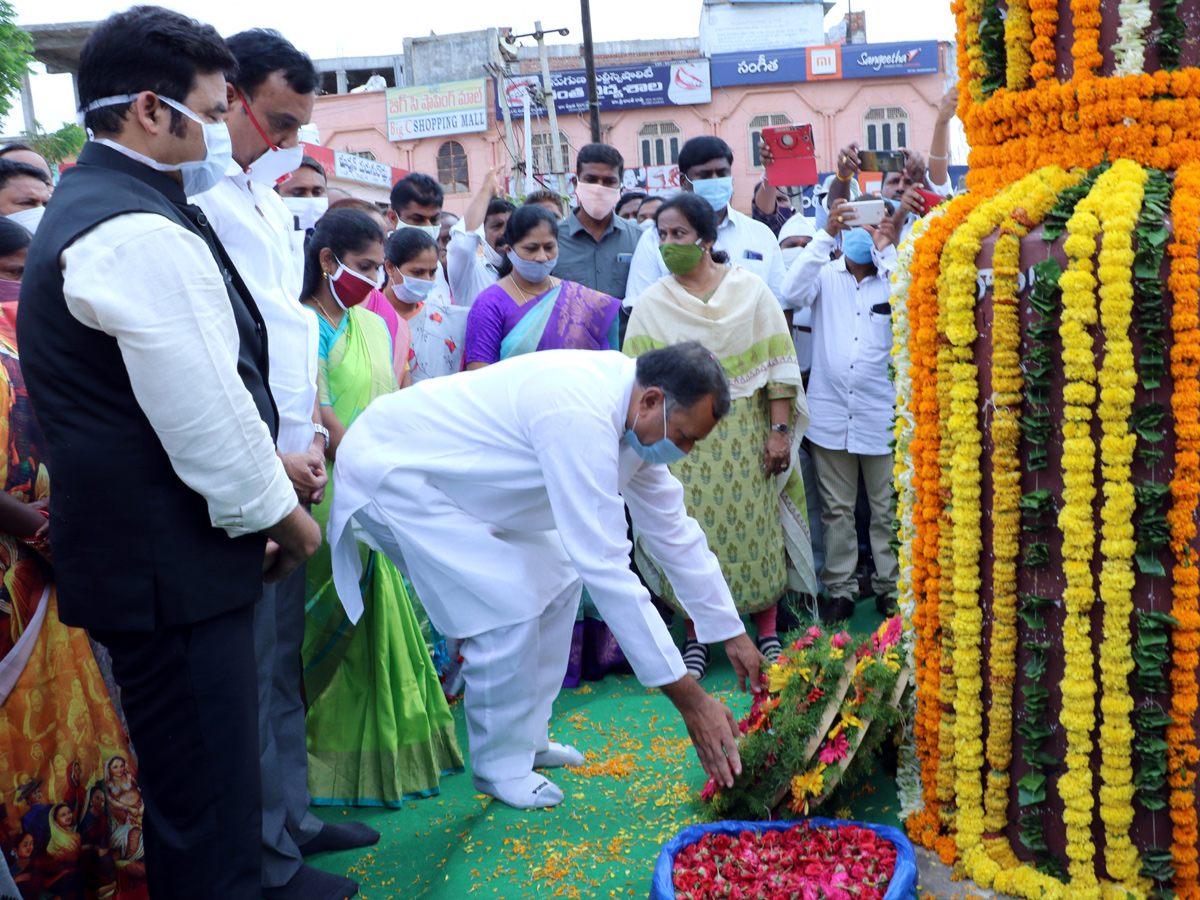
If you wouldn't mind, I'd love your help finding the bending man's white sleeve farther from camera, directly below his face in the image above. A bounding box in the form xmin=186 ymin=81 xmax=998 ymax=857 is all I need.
xmin=624 ymin=460 xmax=744 ymax=643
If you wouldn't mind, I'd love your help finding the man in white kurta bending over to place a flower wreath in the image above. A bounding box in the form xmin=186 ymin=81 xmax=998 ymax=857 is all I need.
xmin=328 ymin=343 xmax=763 ymax=808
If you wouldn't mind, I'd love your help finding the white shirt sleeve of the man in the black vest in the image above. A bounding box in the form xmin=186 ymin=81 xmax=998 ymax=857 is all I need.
xmin=60 ymin=212 xmax=296 ymax=538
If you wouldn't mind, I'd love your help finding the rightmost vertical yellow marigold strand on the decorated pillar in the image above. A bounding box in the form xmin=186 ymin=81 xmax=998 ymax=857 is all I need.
xmin=1097 ymin=160 xmax=1146 ymax=896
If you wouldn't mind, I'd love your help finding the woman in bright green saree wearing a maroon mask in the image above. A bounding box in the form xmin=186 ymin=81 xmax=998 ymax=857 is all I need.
xmin=302 ymin=209 xmax=463 ymax=806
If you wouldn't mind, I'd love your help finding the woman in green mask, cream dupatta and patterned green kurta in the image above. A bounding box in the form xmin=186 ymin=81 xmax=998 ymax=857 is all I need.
xmin=624 ymin=193 xmax=816 ymax=679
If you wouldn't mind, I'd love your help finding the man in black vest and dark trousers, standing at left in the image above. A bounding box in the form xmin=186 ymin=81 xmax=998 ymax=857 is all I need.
xmin=17 ymin=6 xmax=320 ymax=900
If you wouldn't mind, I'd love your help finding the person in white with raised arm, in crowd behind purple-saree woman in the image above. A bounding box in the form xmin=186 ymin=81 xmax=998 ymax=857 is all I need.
xmin=445 ymin=167 xmax=516 ymax=306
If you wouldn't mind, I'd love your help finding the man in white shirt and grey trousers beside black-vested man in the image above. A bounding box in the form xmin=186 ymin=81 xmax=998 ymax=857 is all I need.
xmin=194 ymin=29 xmax=379 ymax=900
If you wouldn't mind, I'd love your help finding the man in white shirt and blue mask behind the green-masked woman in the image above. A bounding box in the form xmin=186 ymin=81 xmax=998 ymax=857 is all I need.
xmin=624 ymin=136 xmax=784 ymax=310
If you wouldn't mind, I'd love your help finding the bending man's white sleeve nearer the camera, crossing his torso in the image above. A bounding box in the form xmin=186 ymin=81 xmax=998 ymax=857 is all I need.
xmin=530 ymin=407 xmax=686 ymax=688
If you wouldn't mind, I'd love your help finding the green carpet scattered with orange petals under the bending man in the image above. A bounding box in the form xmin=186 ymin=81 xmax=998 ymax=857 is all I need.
xmin=310 ymin=602 xmax=898 ymax=900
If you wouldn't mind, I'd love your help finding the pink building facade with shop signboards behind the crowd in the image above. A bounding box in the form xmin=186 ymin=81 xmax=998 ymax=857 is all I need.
xmin=313 ymin=4 xmax=954 ymax=214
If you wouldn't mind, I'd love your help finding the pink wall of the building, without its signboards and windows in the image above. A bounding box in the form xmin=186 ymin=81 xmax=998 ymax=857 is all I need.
xmin=313 ymin=74 xmax=943 ymax=215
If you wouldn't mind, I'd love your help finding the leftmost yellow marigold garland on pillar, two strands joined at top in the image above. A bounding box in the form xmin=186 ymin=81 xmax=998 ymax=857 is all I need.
xmin=938 ymin=167 xmax=1080 ymax=887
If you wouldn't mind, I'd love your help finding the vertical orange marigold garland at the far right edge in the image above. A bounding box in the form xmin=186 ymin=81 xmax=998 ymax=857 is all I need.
xmin=1166 ymin=162 xmax=1200 ymax=900
